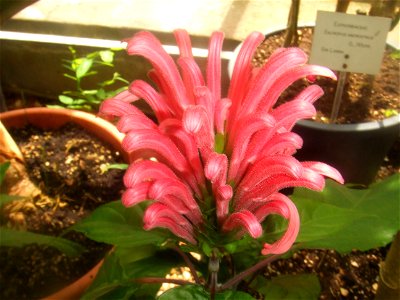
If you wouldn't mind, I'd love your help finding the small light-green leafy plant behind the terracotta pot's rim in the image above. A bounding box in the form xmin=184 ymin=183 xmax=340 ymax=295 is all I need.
xmin=48 ymin=46 xmax=128 ymax=111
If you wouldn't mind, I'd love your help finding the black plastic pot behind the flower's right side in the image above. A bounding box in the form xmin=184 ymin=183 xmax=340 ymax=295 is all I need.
xmin=293 ymin=115 xmax=400 ymax=185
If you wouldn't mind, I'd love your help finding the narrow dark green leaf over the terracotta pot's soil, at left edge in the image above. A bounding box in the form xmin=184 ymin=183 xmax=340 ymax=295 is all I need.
xmin=0 ymin=227 xmax=84 ymax=256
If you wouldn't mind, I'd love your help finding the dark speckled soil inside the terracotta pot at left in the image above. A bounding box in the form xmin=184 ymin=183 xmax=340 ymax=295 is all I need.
xmin=0 ymin=124 xmax=123 ymax=300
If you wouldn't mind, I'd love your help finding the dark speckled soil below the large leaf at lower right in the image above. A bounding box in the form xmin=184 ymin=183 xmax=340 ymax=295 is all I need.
xmin=264 ymin=247 xmax=388 ymax=300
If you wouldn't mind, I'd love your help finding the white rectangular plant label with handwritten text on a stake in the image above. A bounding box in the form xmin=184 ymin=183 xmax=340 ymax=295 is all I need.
xmin=310 ymin=11 xmax=391 ymax=74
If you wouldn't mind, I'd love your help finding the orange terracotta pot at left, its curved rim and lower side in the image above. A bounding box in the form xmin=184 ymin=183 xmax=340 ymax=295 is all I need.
xmin=0 ymin=107 xmax=128 ymax=300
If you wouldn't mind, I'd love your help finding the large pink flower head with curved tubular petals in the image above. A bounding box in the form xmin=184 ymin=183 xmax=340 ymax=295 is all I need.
xmin=100 ymin=30 xmax=343 ymax=255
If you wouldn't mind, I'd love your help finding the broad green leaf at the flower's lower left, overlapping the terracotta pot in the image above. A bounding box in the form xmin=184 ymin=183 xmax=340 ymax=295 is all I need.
xmin=71 ymin=201 xmax=166 ymax=247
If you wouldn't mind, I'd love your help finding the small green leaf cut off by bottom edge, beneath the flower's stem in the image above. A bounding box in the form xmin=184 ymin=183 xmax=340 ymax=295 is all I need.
xmin=158 ymin=284 xmax=209 ymax=300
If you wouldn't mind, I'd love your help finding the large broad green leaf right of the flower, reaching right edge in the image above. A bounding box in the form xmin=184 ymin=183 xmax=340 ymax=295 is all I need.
xmin=291 ymin=174 xmax=400 ymax=253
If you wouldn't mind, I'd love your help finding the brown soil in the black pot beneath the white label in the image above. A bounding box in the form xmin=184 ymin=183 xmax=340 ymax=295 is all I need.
xmin=253 ymin=28 xmax=400 ymax=124
